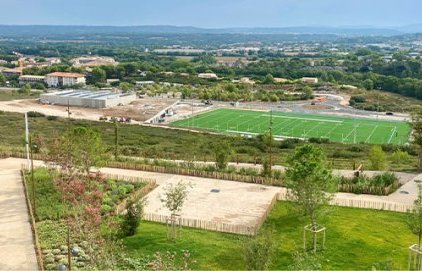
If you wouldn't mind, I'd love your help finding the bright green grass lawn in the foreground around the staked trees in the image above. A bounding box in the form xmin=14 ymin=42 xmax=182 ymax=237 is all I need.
xmin=124 ymin=202 xmax=417 ymax=270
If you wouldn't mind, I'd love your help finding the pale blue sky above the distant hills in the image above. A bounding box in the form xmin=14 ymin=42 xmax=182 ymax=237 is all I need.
xmin=0 ymin=0 xmax=422 ymax=28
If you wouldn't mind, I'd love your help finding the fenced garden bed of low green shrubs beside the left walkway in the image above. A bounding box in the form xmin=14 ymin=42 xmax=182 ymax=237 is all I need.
xmin=26 ymin=168 xmax=150 ymax=270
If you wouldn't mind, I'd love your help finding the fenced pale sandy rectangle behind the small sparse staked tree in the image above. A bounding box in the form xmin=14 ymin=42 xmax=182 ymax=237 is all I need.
xmin=145 ymin=176 xmax=280 ymax=226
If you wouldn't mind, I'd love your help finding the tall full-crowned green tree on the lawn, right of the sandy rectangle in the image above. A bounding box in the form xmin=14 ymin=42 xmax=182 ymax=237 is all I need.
xmin=286 ymin=145 xmax=336 ymax=252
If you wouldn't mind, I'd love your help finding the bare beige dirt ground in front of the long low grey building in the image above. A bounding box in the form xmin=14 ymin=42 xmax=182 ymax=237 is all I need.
xmin=0 ymin=98 xmax=174 ymax=122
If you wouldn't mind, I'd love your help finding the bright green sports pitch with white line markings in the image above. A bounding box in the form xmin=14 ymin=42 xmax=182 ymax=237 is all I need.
xmin=171 ymin=109 xmax=410 ymax=144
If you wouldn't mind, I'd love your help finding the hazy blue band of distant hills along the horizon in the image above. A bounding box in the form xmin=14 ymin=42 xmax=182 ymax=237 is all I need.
xmin=0 ymin=25 xmax=410 ymax=37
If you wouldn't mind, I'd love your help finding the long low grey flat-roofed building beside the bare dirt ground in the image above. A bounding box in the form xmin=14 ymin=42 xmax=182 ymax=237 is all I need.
xmin=40 ymin=90 xmax=136 ymax=108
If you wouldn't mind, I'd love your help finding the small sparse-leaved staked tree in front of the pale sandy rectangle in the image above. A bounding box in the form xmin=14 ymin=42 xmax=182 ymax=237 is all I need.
xmin=161 ymin=181 xmax=190 ymax=240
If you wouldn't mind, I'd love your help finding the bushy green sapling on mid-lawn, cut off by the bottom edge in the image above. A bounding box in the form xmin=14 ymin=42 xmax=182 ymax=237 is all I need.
xmin=243 ymin=232 xmax=273 ymax=270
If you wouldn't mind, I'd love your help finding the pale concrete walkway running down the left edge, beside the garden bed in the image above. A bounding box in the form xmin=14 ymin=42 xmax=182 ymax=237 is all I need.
xmin=0 ymin=166 xmax=38 ymax=270
